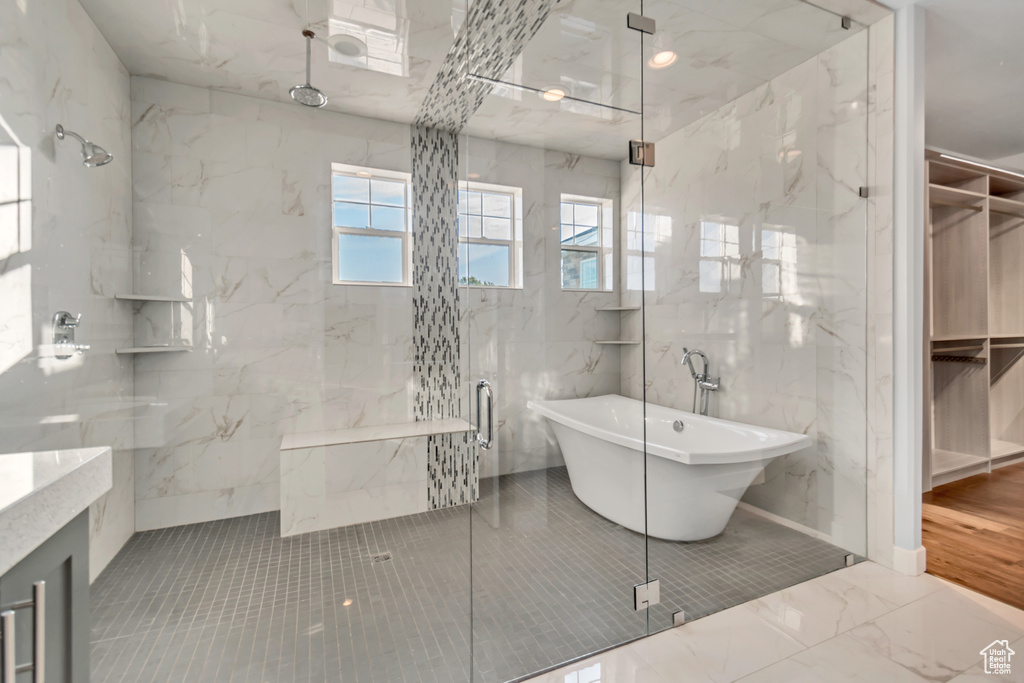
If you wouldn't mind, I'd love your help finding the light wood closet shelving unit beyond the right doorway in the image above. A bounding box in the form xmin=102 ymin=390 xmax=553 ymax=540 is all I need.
xmin=925 ymin=152 xmax=1024 ymax=486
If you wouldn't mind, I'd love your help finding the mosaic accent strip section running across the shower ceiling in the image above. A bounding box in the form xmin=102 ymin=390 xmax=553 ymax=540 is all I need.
xmin=416 ymin=0 xmax=555 ymax=132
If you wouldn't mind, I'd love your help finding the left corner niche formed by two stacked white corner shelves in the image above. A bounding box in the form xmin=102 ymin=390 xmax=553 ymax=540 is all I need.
xmin=114 ymin=294 xmax=193 ymax=354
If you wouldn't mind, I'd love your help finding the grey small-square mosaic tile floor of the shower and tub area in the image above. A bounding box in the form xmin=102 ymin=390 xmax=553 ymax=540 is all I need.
xmin=91 ymin=468 xmax=846 ymax=683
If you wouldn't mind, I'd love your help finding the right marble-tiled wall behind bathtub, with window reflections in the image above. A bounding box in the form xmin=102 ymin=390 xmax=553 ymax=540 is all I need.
xmin=621 ymin=32 xmax=869 ymax=553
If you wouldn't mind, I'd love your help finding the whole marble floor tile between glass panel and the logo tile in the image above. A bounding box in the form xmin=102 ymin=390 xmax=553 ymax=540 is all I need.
xmin=745 ymin=572 xmax=898 ymax=646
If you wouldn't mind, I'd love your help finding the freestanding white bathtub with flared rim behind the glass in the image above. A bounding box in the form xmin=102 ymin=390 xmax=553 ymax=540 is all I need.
xmin=528 ymin=395 xmax=811 ymax=541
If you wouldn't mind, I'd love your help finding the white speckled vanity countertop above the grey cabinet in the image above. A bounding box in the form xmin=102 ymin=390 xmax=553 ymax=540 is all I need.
xmin=0 ymin=446 xmax=112 ymax=574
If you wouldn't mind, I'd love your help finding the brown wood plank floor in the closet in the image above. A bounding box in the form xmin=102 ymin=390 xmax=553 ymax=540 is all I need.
xmin=922 ymin=463 xmax=1024 ymax=609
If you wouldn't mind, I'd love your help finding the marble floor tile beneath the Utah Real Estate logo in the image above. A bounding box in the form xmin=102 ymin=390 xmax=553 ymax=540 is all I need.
xmin=848 ymin=587 xmax=1024 ymax=681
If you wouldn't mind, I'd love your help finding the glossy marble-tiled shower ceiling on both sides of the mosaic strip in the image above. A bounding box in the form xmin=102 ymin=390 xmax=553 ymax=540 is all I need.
xmin=82 ymin=0 xmax=872 ymax=159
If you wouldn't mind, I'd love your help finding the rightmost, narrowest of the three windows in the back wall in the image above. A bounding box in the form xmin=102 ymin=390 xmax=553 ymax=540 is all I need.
xmin=560 ymin=195 xmax=613 ymax=291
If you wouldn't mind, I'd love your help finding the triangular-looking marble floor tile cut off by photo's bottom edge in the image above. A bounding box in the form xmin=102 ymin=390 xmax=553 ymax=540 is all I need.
xmin=739 ymin=636 xmax=929 ymax=683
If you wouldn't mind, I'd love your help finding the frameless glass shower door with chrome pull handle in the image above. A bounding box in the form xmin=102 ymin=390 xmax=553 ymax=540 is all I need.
xmin=458 ymin=2 xmax=647 ymax=682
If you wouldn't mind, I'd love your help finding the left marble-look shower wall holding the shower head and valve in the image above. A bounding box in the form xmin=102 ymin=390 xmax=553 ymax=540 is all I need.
xmin=0 ymin=0 xmax=135 ymax=578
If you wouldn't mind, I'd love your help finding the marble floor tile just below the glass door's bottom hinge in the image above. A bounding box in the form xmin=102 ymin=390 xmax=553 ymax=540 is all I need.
xmin=632 ymin=606 xmax=804 ymax=683
